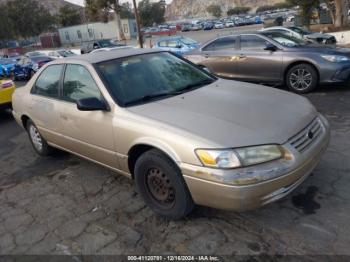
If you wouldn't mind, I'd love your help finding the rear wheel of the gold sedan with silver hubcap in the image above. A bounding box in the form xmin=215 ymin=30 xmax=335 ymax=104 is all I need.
xmin=26 ymin=119 xmax=53 ymax=156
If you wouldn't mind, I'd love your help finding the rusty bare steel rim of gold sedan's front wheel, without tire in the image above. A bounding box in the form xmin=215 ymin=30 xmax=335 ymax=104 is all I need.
xmin=146 ymin=168 xmax=175 ymax=206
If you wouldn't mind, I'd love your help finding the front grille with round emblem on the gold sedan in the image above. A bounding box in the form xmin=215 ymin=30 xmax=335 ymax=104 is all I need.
xmin=288 ymin=117 xmax=324 ymax=153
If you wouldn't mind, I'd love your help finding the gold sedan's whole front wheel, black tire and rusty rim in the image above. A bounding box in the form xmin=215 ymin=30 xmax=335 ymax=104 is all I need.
xmin=134 ymin=149 xmax=194 ymax=220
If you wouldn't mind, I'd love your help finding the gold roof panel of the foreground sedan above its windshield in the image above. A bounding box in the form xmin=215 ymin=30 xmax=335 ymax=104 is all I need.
xmin=61 ymin=48 xmax=161 ymax=64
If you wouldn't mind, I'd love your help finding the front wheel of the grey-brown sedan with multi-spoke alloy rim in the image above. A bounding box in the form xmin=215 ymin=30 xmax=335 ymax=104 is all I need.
xmin=286 ymin=64 xmax=318 ymax=94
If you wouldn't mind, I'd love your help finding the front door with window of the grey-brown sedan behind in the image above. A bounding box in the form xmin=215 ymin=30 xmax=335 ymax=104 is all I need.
xmin=237 ymin=35 xmax=283 ymax=83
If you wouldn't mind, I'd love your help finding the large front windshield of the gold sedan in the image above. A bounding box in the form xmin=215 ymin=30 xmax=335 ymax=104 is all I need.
xmin=96 ymin=52 xmax=216 ymax=106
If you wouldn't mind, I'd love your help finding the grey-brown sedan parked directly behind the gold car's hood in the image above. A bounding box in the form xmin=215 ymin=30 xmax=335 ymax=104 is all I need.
xmin=186 ymin=31 xmax=350 ymax=93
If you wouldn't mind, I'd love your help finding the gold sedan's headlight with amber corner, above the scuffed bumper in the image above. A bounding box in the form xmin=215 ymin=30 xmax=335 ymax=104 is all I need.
xmin=196 ymin=145 xmax=283 ymax=169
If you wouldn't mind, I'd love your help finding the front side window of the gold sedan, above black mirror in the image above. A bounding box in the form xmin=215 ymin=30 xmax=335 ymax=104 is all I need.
xmin=62 ymin=65 xmax=102 ymax=102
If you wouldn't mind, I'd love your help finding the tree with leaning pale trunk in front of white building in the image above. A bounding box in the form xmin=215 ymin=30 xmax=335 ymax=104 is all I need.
xmin=85 ymin=0 xmax=125 ymax=40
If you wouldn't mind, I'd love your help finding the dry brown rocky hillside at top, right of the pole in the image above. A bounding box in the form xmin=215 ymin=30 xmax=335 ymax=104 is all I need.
xmin=166 ymin=0 xmax=284 ymax=20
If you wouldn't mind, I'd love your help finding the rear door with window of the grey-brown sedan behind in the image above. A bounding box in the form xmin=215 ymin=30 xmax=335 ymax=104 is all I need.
xmin=200 ymin=36 xmax=239 ymax=78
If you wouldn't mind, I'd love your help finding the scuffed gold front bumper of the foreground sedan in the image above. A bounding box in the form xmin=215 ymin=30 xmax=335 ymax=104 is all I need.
xmin=181 ymin=114 xmax=330 ymax=211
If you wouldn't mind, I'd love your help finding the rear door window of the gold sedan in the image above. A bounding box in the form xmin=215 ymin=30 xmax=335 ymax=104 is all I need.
xmin=31 ymin=65 xmax=63 ymax=98
